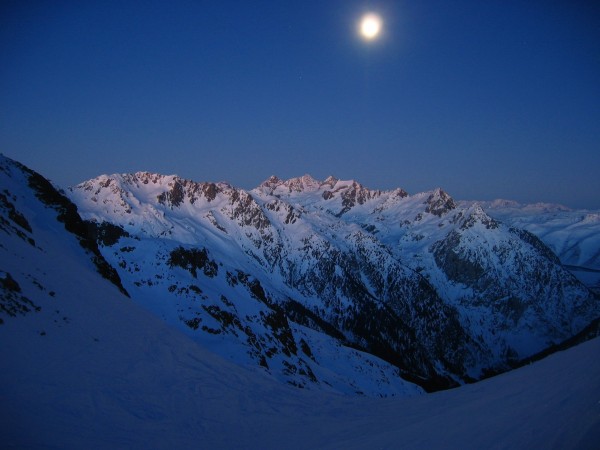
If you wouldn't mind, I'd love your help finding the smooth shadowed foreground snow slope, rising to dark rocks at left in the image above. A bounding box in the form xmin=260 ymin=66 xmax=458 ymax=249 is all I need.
xmin=0 ymin=154 xmax=600 ymax=449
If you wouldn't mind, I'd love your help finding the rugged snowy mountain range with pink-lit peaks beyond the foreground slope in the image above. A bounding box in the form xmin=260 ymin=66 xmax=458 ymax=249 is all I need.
xmin=68 ymin=172 xmax=600 ymax=395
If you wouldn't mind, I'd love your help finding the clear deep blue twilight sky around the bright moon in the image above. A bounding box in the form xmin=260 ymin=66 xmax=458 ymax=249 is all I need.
xmin=0 ymin=0 xmax=600 ymax=208
